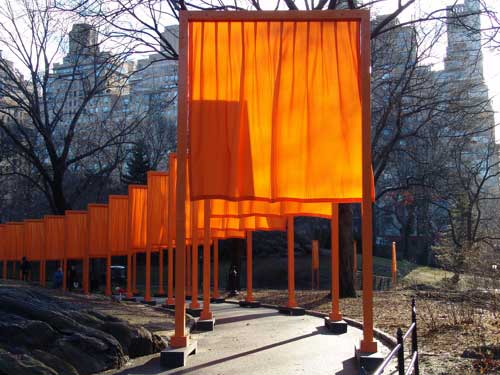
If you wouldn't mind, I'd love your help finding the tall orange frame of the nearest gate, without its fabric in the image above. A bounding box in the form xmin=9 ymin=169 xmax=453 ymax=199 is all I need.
xmin=176 ymin=10 xmax=377 ymax=353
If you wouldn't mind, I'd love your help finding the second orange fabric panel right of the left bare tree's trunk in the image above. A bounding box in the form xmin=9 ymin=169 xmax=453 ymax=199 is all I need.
xmin=87 ymin=204 xmax=109 ymax=257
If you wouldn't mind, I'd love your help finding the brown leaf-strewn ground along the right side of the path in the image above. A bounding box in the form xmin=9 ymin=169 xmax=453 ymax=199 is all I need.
xmin=234 ymin=288 xmax=500 ymax=375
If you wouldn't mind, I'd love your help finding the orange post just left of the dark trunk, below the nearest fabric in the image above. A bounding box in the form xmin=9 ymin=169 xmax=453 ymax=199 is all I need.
xmin=330 ymin=203 xmax=342 ymax=321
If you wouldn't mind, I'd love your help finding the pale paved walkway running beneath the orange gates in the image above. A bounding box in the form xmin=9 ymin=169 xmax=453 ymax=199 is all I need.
xmin=112 ymin=303 xmax=388 ymax=375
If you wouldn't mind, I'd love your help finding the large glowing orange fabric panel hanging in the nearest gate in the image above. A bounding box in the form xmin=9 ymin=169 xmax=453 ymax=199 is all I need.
xmin=188 ymin=20 xmax=362 ymax=202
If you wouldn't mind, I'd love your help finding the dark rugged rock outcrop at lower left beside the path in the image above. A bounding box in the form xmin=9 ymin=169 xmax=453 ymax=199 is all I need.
xmin=0 ymin=286 xmax=165 ymax=375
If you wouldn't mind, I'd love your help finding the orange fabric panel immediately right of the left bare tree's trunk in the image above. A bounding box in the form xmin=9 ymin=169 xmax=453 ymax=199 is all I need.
xmin=64 ymin=211 xmax=89 ymax=259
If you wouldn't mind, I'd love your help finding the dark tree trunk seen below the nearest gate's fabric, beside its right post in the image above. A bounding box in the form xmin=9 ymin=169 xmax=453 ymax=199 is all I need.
xmin=339 ymin=204 xmax=356 ymax=297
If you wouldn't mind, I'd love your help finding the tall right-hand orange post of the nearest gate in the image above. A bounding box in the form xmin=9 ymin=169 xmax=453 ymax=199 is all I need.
xmin=359 ymin=16 xmax=377 ymax=353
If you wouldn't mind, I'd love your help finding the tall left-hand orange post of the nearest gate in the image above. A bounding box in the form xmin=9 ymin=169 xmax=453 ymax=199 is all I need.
xmin=170 ymin=14 xmax=189 ymax=348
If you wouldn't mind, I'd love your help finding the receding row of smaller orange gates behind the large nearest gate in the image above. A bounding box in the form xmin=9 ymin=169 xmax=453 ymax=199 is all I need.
xmin=0 ymin=153 xmax=350 ymax=306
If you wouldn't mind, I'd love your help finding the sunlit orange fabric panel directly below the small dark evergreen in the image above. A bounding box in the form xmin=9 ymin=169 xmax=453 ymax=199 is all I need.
xmin=128 ymin=185 xmax=148 ymax=250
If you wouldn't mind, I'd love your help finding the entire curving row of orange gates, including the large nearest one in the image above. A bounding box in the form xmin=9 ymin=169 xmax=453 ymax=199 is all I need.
xmin=0 ymin=10 xmax=377 ymax=364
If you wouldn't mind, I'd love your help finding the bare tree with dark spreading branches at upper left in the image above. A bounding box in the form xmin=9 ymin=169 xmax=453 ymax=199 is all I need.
xmin=0 ymin=0 xmax=148 ymax=213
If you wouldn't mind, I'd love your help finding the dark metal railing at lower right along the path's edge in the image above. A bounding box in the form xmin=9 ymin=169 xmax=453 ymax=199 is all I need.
xmin=373 ymin=298 xmax=420 ymax=375
